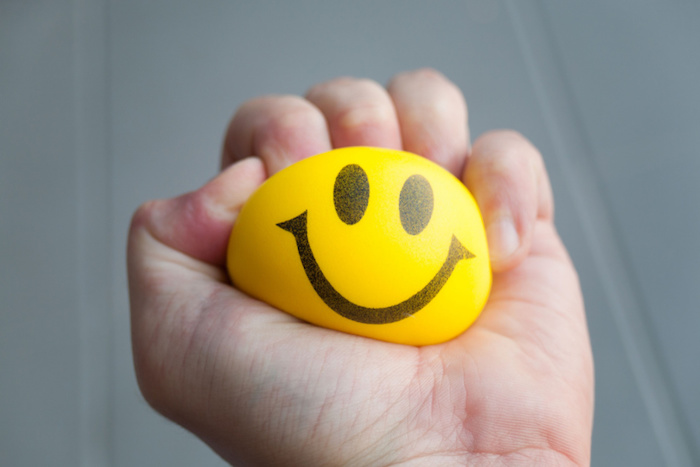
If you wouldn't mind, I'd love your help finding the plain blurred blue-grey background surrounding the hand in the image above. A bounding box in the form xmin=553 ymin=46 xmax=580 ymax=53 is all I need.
xmin=0 ymin=0 xmax=700 ymax=466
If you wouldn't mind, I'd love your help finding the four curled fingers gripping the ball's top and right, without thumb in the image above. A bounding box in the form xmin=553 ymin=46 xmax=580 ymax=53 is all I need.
xmin=222 ymin=69 xmax=553 ymax=272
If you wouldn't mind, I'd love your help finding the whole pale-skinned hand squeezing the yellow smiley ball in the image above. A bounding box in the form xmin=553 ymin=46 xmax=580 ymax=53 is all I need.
xmin=128 ymin=70 xmax=593 ymax=466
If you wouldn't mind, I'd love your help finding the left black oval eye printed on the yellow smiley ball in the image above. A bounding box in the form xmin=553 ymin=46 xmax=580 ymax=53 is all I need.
xmin=333 ymin=164 xmax=369 ymax=225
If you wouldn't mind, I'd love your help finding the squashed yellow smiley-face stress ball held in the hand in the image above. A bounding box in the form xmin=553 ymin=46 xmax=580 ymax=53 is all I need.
xmin=228 ymin=147 xmax=491 ymax=345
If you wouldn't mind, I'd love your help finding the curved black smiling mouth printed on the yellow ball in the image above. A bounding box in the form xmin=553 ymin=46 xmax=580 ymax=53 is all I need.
xmin=277 ymin=211 xmax=475 ymax=324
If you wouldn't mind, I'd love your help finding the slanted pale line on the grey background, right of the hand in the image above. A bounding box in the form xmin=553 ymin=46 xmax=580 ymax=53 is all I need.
xmin=506 ymin=0 xmax=699 ymax=466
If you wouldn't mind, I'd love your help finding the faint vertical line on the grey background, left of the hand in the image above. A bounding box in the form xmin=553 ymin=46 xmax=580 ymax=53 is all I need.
xmin=72 ymin=0 xmax=113 ymax=467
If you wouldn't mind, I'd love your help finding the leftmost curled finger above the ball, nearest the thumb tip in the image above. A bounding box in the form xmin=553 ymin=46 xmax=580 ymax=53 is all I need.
xmin=221 ymin=96 xmax=331 ymax=175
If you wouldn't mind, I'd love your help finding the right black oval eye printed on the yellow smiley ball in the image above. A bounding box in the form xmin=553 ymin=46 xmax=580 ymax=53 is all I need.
xmin=399 ymin=175 xmax=433 ymax=235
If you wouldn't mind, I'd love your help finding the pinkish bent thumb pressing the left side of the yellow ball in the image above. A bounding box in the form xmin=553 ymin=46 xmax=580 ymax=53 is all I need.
xmin=129 ymin=158 xmax=265 ymax=266
